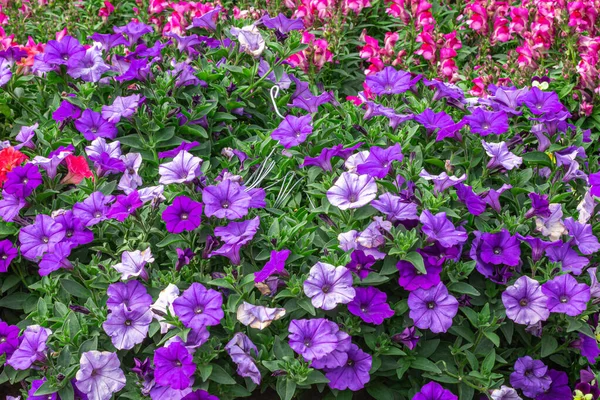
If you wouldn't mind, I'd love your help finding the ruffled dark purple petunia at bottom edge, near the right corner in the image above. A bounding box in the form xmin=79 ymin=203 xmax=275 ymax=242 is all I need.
xmin=510 ymin=356 xmax=552 ymax=397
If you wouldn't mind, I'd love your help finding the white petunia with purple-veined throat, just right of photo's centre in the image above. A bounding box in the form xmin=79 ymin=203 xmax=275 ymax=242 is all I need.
xmin=327 ymin=172 xmax=377 ymax=210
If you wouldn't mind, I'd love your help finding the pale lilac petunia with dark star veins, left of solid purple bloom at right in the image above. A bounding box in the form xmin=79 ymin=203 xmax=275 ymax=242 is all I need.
xmin=502 ymin=276 xmax=550 ymax=325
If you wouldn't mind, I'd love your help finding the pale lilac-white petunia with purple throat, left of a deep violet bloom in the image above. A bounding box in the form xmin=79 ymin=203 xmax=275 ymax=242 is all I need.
xmin=304 ymin=262 xmax=356 ymax=310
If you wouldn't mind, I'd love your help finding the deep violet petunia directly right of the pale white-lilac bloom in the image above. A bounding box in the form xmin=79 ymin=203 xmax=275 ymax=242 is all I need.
xmin=348 ymin=286 xmax=394 ymax=325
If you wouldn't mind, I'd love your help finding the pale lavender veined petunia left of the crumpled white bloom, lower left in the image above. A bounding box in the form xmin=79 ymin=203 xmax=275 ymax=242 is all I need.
xmin=102 ymin=305 xmax=152 ymax=350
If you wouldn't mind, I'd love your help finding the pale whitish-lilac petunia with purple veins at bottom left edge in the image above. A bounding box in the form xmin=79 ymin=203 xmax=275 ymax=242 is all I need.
xmin=75 ymin=351 xmax=126 ymax=400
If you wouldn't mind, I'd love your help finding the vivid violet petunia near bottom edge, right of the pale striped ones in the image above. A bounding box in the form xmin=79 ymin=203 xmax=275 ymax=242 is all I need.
xmin=154 ymin=342 xmax=196 ymax=389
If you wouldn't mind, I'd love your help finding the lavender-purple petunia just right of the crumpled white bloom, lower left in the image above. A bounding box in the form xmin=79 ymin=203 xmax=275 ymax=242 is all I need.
xmin=173 ymin=282 xmax=225 ymax=330
